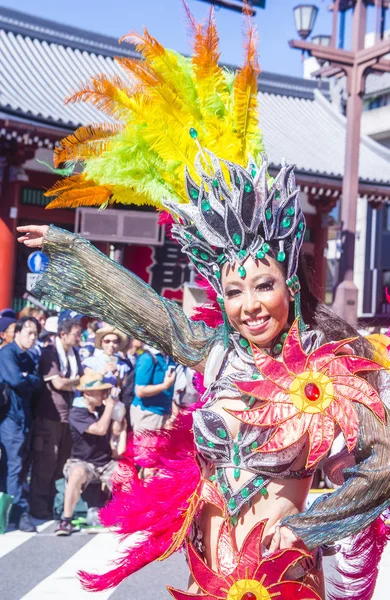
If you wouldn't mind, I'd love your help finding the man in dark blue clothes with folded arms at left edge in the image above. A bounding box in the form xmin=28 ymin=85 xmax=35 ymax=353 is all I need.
xmin=0 ymin=317 xmax=41 ymax=532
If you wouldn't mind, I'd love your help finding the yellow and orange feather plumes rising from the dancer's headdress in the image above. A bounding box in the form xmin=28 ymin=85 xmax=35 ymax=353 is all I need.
xmin=46 ymin=7 xmax=263 ymax=208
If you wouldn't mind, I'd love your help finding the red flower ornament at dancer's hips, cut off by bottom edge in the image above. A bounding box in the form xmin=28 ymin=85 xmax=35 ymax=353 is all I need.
xmin=168 ymin=521 xmax=320 ymax=600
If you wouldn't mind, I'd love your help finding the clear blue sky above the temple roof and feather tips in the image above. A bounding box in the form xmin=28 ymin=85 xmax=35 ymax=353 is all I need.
xmin=0 ymin=0 xmax=362 ymax=77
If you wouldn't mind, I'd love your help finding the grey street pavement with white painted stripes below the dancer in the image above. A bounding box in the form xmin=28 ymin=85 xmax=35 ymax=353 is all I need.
xmin=0 ymin=521 xmax=390 ymax=600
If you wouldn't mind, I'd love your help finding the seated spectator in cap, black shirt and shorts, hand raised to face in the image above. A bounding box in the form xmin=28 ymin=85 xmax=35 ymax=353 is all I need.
xmin=56 ymin=371 xmax=126 ymax=536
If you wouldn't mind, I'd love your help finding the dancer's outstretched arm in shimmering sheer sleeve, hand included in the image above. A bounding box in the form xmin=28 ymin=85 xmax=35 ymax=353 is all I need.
xmin=18 ymin=226 xmax=219 ymax=367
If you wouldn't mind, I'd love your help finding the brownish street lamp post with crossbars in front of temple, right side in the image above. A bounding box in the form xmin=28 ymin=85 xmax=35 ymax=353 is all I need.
xmin=289 ymin=0 xmax=390 ymax=325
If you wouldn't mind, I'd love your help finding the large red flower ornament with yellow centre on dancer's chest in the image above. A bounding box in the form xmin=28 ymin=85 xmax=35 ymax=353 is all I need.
xmin=228 ymin=321 xmax=386 ymax=468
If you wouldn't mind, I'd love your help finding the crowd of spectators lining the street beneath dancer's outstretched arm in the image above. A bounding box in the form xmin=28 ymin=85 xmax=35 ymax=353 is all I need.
xmin=0 ymin=307 xmax=192 ymax=536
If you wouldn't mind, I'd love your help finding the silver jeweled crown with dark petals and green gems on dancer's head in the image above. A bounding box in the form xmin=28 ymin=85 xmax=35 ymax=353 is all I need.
xmin=164 ymin=150 xmax=305 ymax=295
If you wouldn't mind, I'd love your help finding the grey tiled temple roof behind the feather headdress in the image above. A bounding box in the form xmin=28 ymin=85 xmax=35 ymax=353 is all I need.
xmin=0 ymin=8 xmax=390 ymax=185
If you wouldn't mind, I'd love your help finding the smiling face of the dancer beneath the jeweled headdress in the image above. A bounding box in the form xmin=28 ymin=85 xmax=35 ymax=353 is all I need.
xmin=222 ymin=257 xmax=291 ymax=348
